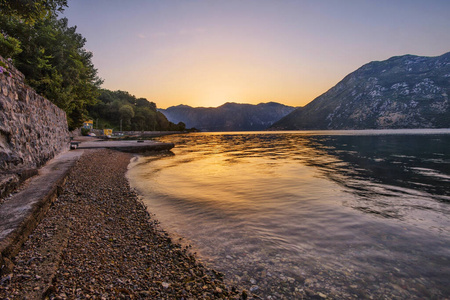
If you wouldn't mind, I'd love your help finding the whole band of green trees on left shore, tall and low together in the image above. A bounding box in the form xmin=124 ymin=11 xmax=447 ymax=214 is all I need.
xmin=0 ymin=0 xmax=184 ymax=130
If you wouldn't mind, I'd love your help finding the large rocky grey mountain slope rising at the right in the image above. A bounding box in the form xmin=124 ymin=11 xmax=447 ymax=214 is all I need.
xmin=271 ymin=52 xmax=450 ymax=130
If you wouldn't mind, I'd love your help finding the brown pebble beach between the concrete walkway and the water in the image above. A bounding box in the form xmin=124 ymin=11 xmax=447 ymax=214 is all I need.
xmin=0 ymin=150 xmax=247 ymax=299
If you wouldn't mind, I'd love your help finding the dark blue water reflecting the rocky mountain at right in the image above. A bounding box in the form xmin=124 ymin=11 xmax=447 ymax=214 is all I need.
xmin=311 ymin=135 xmax=450 ymax=203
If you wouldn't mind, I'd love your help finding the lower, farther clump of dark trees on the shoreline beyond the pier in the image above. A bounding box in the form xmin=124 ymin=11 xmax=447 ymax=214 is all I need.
xmin=88 ymin=89 xmax=185 ymax=131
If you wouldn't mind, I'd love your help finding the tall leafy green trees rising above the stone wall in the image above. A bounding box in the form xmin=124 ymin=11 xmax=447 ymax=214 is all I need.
xmin=0 ymin=0 xmax=101 ymax=129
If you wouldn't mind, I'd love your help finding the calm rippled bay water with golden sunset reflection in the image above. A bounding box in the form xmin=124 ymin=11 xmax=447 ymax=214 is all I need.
xmin=129 ymin=130 xmax=450 ymax=299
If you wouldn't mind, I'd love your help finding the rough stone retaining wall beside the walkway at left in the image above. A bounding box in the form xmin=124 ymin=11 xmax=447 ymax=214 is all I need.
xmin=0 ymin=56 xmax=69 ymax=197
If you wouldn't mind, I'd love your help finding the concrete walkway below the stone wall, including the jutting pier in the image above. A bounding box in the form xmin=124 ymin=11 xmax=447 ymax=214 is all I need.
xmin=0 ymin=137 xmax=174 ymax=276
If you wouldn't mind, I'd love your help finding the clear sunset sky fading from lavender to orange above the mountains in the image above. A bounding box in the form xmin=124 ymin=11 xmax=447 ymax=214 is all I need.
xmin=63 ymin=0 xmax=450 ymax=108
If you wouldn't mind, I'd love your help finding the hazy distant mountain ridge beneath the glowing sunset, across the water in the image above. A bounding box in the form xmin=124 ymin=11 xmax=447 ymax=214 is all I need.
xmin=159 ymin=102 xmax=295 ymax=131
